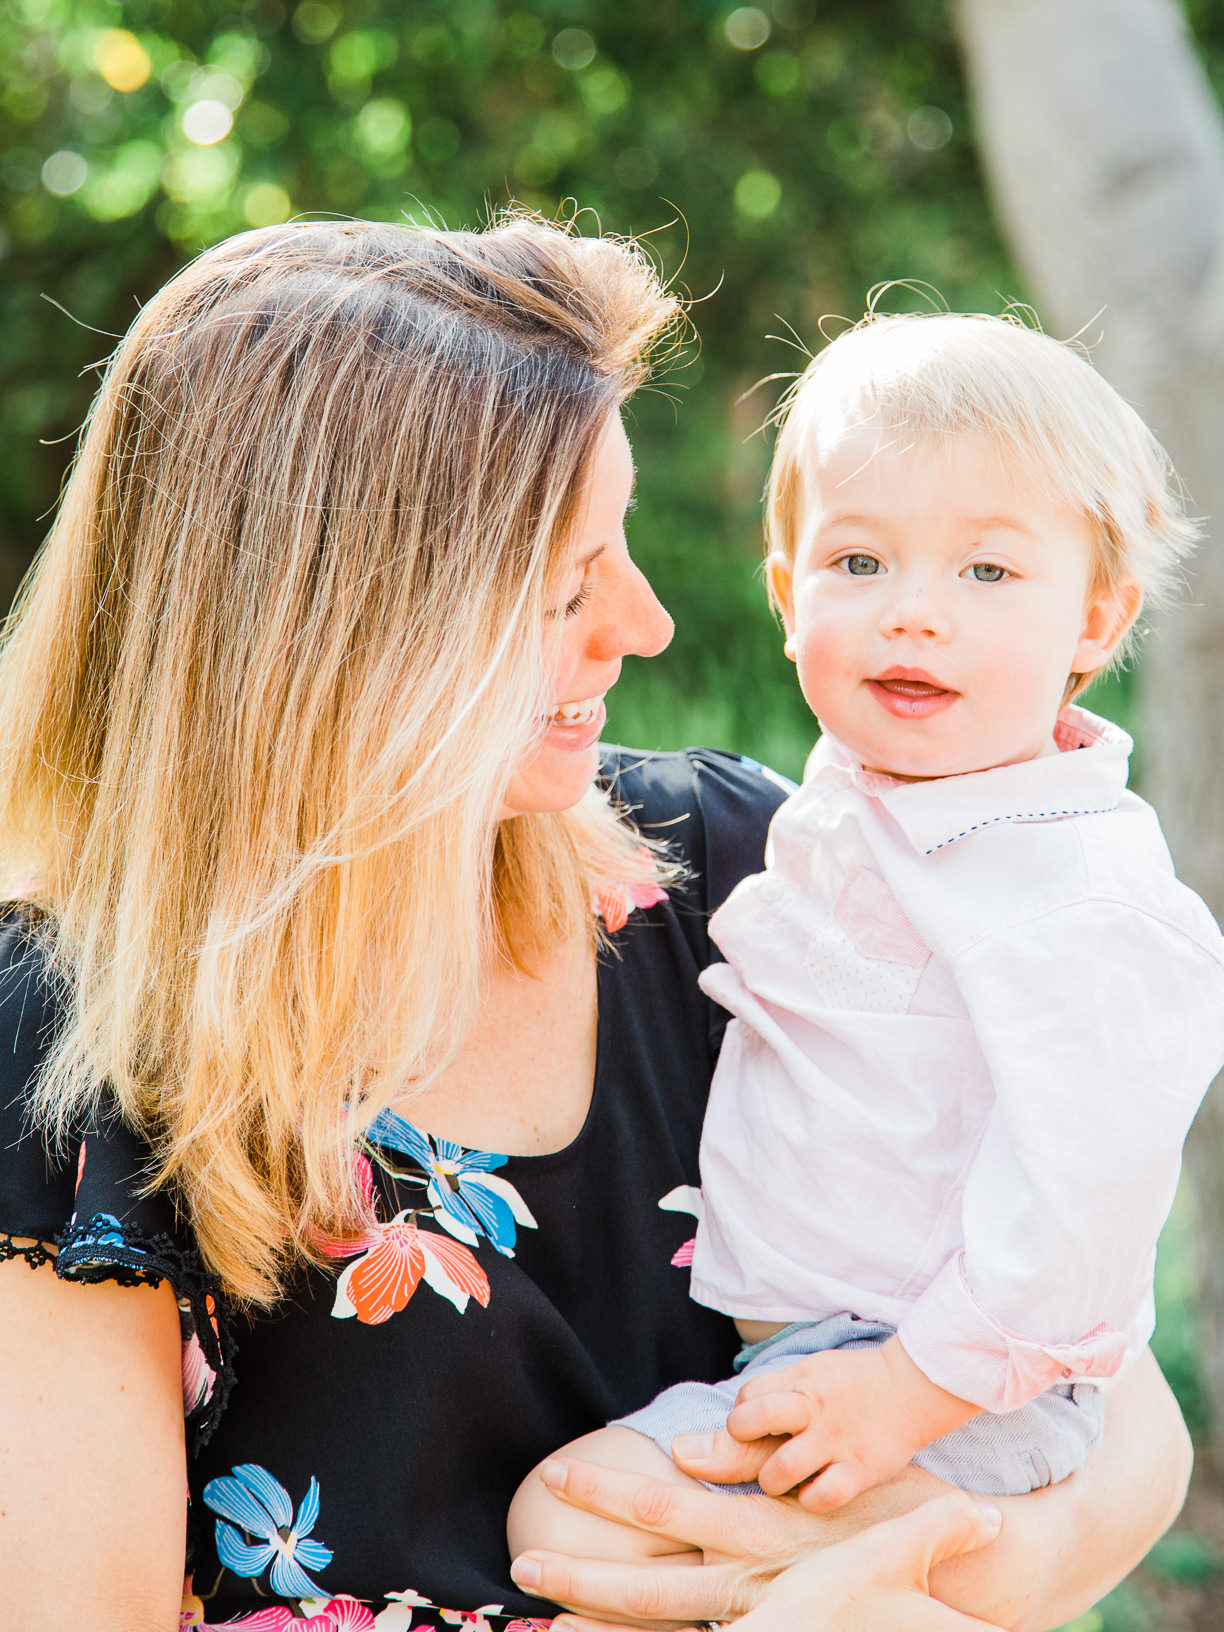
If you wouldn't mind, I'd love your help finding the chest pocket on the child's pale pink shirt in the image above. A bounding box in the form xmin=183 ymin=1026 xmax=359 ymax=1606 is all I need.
xmin=805 ymin=867 xmax=930 ymax=1013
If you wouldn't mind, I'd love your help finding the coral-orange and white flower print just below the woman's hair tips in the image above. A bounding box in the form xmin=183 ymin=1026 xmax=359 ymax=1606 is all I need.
xmin=331 ymin=1155 xmax=490 ymax=1325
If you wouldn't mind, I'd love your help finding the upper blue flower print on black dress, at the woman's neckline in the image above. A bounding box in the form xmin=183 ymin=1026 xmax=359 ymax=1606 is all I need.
xmin=367 ymin=1110 xmax=535 ymax=1258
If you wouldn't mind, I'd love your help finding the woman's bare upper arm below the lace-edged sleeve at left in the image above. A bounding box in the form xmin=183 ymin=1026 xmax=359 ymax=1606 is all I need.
xmin=0 ymin=1258 xmax=186 ymax=1632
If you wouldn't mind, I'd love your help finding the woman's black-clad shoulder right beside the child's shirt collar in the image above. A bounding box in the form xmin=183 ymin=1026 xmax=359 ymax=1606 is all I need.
xmin=602 ymin=747 xmax=793 ymax=912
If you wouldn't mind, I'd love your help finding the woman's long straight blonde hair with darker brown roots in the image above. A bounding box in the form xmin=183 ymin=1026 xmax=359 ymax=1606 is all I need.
xmin=0 ymin=217 xmax=677 ymax=1302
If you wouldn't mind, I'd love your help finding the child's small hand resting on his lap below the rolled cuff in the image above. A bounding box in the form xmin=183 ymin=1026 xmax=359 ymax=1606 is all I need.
xmin=674 ymin=1337 xmax=978 ymax=1513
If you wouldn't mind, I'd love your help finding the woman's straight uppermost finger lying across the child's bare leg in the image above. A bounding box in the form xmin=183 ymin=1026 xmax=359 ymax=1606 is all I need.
xmin=540 ymin=1457 xmax=796 ymax=1553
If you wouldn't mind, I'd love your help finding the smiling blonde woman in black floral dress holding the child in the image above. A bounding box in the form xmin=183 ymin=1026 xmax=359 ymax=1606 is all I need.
xmin=0 ymin=220 xmax=1188 ymax=1632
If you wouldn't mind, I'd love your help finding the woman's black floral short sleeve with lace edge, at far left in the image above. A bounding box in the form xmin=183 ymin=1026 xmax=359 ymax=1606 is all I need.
xmin=0 ymin=907 xmax=233 ymax=1451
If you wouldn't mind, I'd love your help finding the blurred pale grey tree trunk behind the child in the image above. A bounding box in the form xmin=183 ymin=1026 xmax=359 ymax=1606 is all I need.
xmin=956 ymin=0 xmax=1224 ymax=1469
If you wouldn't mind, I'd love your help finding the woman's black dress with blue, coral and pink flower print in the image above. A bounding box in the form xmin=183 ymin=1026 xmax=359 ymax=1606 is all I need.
xmin=0 ymin=751 xmax=785 ymax=1632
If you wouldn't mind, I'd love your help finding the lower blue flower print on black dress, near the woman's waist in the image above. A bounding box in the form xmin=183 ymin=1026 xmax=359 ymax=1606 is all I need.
xmin=204 ymin=1462 xmax=331 ymax=1598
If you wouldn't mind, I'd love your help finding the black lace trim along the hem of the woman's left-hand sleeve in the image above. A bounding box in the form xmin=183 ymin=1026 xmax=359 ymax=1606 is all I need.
xmin=55 ymin=1213 xmax=237 ymax=1456
